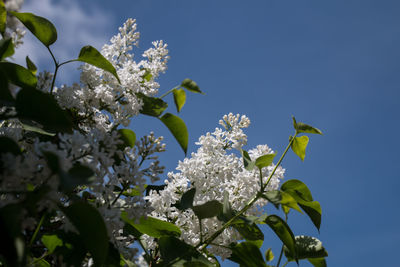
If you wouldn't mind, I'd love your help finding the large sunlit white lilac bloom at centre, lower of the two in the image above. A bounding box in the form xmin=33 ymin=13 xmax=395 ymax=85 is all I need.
xmin=147 ymin=114 xmax=284 ymax=258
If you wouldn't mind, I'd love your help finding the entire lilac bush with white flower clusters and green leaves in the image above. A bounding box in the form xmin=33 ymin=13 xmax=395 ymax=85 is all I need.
xmin=0 ymin=1 xmax=327 ymax=267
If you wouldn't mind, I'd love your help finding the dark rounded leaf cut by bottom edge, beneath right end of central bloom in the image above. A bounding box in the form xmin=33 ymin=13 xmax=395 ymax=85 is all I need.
xmin=229 ymin=242 xmax=266 ymax=267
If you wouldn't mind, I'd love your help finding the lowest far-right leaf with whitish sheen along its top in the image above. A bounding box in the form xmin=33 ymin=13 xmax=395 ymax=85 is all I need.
xmin=284 ymin=235 xmax=328 ymax=261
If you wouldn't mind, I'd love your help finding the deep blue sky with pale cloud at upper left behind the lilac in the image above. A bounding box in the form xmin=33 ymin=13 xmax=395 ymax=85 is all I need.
xmin=17 ymin=0 xmax=400 ymax=266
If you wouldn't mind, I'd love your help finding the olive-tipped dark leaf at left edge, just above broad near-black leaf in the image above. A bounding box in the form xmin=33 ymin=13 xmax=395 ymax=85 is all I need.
xmin=0 ymin=62 xmax=37 ymax=88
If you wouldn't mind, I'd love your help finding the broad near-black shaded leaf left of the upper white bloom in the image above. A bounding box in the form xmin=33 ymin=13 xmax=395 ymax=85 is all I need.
xmin=16 ymin=88 xmax=72 ymax=133
